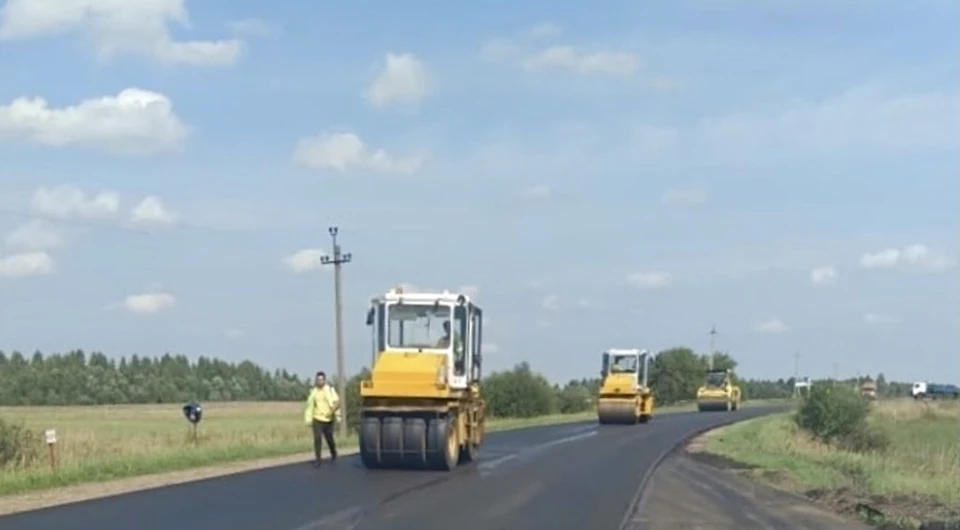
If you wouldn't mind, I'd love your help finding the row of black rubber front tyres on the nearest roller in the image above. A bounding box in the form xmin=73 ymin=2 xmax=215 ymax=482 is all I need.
xmin=360 ymin=416 xmax=464 ymax=470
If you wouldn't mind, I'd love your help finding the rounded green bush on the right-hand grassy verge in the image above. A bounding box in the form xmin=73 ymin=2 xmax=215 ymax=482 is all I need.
xmin=794 ymin=382 xmax=888 ymax=452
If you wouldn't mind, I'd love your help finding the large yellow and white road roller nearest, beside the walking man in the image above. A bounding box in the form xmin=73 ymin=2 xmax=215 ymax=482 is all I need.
xmin=359 ymin=287 xmax=486 ymax=471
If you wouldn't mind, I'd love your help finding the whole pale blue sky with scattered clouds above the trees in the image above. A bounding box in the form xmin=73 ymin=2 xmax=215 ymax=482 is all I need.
xmin=0 ymin=0 xmax=960 ymax=381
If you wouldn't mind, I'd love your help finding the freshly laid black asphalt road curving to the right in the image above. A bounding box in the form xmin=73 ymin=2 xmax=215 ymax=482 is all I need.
xmin=0 ymin=407 xmax=779 ymax=530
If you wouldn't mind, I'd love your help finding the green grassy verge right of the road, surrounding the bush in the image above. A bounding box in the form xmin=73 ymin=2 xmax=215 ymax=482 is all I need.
xmin=705 ymin=399 xmax=960 ymax=528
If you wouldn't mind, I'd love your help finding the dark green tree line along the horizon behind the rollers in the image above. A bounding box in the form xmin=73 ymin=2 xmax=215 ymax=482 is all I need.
xmin=0 ymin=347 xmax=910 ymax=417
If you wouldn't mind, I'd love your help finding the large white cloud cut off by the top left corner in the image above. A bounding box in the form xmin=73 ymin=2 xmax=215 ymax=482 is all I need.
xmin=0 ymin=0 xmax=243 ymax=66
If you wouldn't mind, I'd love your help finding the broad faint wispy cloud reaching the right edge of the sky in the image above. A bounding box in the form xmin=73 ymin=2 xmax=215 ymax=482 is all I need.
xmin=697 ymin=87 xmax=960 ymax=161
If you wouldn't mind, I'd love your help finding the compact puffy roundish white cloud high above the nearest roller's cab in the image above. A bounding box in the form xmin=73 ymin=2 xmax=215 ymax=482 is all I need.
xmin=364 ymin=53 xmax=432 ymax=108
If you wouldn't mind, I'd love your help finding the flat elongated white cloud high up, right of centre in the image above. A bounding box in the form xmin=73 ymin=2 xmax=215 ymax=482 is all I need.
xmin=521 ymin=46 xmax=643 ymax=76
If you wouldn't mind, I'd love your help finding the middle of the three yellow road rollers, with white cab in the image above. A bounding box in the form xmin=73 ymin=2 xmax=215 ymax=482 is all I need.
xmin=597 ymin=349 xmax=653 ymax=425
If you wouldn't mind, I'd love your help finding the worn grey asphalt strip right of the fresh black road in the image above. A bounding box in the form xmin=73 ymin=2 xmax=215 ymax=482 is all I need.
xmin=628 ymin=428 xmax=870 ymax=530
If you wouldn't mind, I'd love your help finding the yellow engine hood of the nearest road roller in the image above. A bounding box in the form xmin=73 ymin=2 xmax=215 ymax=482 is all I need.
xmin=360 ymin=350 xmax=448 ymax=397
